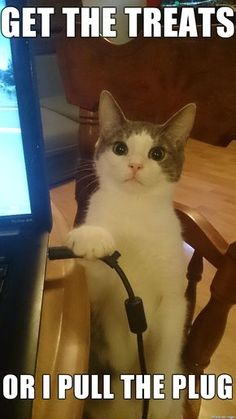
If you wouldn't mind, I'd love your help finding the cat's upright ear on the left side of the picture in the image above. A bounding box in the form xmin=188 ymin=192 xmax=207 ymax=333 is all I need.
xmin=98 ymin=90 xmax=126 ymax=133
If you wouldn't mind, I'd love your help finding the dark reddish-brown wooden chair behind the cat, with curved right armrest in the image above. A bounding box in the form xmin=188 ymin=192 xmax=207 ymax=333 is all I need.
xmin=55 ymin=24 xmax=236 ymax=419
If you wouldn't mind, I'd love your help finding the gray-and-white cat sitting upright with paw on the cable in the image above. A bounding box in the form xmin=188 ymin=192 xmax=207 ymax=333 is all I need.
xmin=68 ymin=91 xmax=196 ymax=419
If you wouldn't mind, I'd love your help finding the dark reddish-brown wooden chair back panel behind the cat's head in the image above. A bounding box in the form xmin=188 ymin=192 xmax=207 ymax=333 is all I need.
xmin=58 ymin=23 xmax=236 ymax=146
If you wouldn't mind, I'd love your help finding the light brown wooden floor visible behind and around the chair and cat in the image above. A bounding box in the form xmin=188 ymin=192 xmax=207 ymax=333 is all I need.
xmin=51 ymin=140 xmax=236 ymax=419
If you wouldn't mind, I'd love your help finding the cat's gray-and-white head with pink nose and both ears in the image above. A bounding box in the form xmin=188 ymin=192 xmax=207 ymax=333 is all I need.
xmin=95 ymin=91 xmax=196 ymax=192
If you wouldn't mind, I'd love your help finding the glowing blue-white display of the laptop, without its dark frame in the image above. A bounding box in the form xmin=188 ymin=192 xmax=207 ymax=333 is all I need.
xmin=0 ymin=0 xmax=31 ymax=220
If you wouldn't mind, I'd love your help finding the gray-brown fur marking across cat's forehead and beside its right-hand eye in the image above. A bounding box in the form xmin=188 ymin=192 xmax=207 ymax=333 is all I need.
xmin=95 ymin=121 xmax=184 ymax=182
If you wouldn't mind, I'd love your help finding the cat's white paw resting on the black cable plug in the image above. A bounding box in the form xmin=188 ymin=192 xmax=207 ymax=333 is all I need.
xmin=67 ymin=225 xmax=115 ymax=259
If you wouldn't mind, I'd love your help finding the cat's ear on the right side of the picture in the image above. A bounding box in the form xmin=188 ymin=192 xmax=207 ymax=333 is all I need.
xmin=162 ymin=103 xmax=196 ymax=146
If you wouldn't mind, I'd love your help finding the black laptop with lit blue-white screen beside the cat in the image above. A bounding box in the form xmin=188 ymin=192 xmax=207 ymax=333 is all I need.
xmin=0 ymin=0 xmax=51 ymax=419
